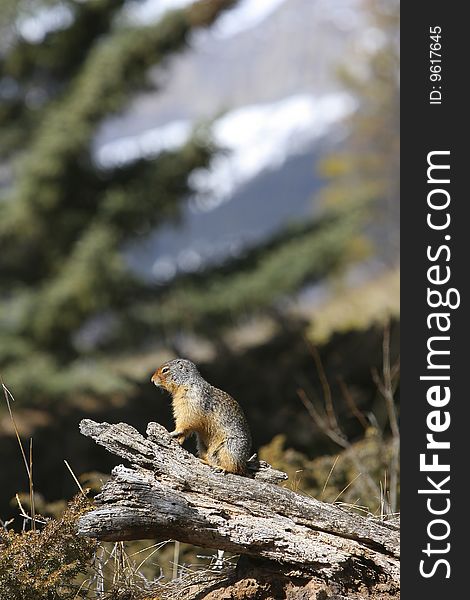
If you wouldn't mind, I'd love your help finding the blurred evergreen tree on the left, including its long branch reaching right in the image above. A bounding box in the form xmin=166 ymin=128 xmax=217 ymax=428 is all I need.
xmin=0 ymin=0 xmax=378 ymax=403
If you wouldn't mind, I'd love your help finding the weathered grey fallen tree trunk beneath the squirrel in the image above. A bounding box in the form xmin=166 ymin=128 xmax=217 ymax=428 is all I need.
xmin=79 ymin=420 xmax=399 ymax=599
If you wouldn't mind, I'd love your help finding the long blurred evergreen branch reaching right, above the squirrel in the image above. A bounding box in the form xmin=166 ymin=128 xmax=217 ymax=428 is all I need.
xmin=126 ymin=210 xmax=365 ymax=332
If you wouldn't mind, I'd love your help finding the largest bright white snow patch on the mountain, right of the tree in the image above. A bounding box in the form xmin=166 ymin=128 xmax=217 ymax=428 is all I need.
xmin=190 ymin=93 xmax=354 ymax=211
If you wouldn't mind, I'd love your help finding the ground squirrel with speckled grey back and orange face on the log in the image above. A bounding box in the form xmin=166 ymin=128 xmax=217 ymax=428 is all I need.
xmin=152 ymin=358 xmax=251 ymax=474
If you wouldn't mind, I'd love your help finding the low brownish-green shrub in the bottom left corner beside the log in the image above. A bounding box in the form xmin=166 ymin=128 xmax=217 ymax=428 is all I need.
xmin=0 ymin=496 xmax=97 ymax=600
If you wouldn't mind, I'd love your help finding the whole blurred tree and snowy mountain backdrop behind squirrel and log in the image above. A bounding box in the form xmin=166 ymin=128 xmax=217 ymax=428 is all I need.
xmin=0 ymin=0 xmax=399 ymax=536
